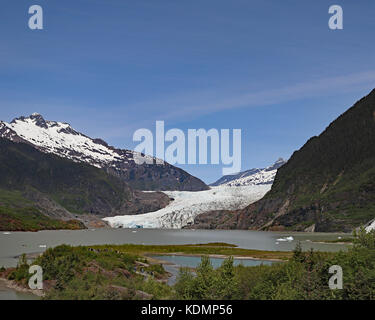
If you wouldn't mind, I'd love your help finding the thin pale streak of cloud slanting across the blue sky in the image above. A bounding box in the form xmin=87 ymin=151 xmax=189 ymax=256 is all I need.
xmin=101 ymin=71 xmax=375 ymax=137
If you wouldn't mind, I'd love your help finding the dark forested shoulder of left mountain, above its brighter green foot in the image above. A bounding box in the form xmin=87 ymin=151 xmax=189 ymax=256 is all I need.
xmin=0 ymin=139 xmax=129 ymax=213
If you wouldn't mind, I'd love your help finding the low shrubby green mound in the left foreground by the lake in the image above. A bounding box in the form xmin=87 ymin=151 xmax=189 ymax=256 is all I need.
xmin=8 ymin=245 xmax=172 ymax=300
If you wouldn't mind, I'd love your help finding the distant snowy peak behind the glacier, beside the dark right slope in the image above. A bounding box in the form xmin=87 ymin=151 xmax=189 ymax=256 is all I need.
xmin=211 ymin=158 xmax=286 ymax=187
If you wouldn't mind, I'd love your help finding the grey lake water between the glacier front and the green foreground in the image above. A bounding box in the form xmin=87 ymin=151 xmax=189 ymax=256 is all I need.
xmin=0 ymin=229 xmax=347 ymax=299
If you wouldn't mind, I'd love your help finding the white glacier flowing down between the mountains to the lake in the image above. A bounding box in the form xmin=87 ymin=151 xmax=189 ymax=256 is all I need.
xmin=103 ymin=185 xmax=271 ymax=229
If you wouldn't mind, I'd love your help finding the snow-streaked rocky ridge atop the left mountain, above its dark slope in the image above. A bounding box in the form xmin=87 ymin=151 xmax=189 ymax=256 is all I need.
xmin=0 ymin=113 xmax=207 ymax=191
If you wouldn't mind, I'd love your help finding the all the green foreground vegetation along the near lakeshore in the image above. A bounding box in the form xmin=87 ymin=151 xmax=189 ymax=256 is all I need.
xmin=4 ymin=229 xmax=375 ymax=300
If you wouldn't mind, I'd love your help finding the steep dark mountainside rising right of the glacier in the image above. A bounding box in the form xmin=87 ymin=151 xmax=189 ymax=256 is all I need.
xmin=192 ymin=90 xmax=375 ymax=232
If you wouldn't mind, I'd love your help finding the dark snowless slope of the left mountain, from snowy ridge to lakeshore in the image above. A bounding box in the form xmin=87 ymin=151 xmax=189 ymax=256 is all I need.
xmin=0 ymin=138 xmax=169 ymax=230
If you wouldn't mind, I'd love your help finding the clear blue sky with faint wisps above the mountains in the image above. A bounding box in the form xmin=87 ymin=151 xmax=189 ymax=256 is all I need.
xmin=0 ymin=0 xmax=375 ymax=182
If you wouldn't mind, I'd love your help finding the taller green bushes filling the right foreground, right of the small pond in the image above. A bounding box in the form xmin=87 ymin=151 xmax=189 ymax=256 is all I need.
xmin=175 ymin=230 xmax=375 ymax=300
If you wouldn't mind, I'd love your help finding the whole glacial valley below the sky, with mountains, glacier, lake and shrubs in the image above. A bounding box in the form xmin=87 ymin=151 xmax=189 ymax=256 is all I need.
xmin=0 ymin=91 xmax=375 ymax=300
